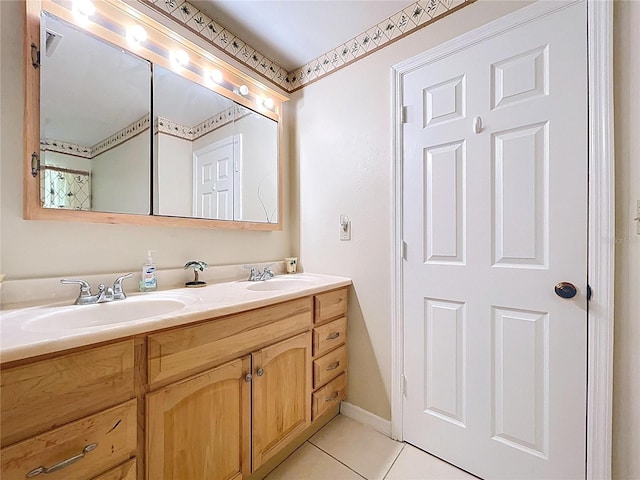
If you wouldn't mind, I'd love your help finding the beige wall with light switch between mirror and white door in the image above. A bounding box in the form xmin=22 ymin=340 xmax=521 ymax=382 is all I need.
xmin=291 ymin=0 xmax=526 ymax=419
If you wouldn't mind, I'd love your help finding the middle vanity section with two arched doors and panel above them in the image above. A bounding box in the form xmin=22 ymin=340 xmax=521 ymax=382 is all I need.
xmin=146 ymin=297 xmax=313 ymax=480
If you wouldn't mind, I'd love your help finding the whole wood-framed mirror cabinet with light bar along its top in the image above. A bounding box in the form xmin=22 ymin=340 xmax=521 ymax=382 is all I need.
xmin=25 ymin=0 xmax=286 ymax=230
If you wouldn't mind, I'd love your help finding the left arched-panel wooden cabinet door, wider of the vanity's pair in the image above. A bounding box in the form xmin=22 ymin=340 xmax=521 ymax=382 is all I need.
xmin=147 ymin=356 xmax=251 ymax=480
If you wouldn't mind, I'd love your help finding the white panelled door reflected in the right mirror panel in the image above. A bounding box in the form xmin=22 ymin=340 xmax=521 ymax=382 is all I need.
xmin=193 ymin=135 xmax=242 ymax=220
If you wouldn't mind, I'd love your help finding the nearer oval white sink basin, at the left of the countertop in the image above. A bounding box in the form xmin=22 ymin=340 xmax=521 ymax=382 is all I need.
xmin=17 ymin=293 xmax=199 ymax=332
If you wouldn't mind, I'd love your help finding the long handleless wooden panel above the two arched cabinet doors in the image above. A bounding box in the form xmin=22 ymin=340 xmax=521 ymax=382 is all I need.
xmin=147 ymin=297 xmax=312 ymax=384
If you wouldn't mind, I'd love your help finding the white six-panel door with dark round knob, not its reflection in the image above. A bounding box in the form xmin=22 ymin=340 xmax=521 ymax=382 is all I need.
xmin=402 ymin=3 xmax=587 ymax=479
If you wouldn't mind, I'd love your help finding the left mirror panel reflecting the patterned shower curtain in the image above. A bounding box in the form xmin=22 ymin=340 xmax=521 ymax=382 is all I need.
xmin=40 ymin=12 xmax=151 ymax=214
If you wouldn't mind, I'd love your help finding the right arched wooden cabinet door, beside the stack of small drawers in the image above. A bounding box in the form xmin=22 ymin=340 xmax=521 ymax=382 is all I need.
xmin=253 ymin=332 xmax=311 ymax=471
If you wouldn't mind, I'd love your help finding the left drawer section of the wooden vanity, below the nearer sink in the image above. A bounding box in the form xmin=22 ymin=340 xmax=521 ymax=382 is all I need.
xmin=0 ymin=340 xmax=137 ymax=480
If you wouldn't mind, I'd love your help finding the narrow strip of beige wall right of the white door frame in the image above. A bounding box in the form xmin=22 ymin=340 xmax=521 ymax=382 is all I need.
xmin=613 ymin=0 xmax=640 ymax=480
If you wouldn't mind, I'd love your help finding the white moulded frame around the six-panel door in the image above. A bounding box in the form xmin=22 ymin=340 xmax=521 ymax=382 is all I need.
xmin=391 ymin=0 xmax=615 ymax=480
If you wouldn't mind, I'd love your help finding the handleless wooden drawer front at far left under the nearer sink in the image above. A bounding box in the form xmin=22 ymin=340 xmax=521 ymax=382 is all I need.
xmin=0 ymin=340 xmax=134 ymax=447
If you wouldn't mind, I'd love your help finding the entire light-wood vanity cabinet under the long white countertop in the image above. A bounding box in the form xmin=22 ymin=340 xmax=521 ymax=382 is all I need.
xmin=0 ymin=287 xmax=348 ymax=480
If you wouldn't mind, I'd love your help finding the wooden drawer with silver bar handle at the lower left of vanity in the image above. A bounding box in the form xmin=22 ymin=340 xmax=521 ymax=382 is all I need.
xmin=0 ymin=399 xmax=137 ymax=480
